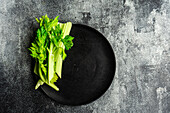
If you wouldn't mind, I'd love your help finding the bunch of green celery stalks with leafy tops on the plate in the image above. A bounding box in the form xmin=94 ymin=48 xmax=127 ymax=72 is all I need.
xmin=29 ymin=15 xmax=74 ymax=91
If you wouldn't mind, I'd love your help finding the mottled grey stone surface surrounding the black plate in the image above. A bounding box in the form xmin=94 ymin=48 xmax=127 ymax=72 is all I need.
xmin=0 ymin=0 xmax=170 ymax=113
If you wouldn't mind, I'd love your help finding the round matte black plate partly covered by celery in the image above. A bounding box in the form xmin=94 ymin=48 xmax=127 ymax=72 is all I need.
xmin=41 ymin=24 xmax=116 ymax=105
